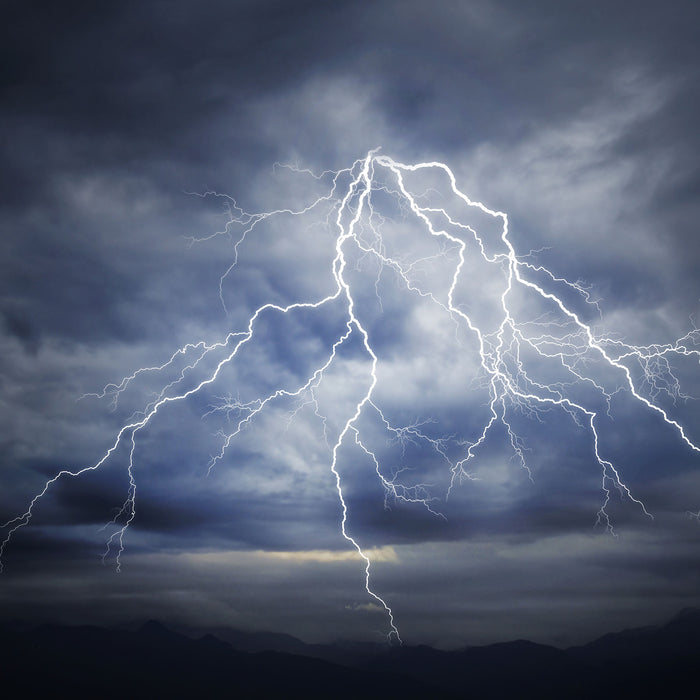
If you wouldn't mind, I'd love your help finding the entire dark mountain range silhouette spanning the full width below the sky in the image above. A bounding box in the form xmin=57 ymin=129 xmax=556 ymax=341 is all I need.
xmin=0 ymin=610 xmax=700 ymax=700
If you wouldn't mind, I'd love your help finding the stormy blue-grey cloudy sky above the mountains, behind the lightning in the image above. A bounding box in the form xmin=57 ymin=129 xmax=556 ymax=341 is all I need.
xmin=0 ymin=0 xmax=700 ymax=646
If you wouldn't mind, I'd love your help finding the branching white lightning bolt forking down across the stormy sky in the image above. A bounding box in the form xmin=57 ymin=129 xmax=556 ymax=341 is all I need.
xmin=0 ymin=150 xmax=700 ymax=643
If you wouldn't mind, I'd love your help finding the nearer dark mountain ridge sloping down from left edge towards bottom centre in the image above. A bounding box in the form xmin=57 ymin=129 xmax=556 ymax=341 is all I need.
xmin=0 ymin=621 xmax=452 ymax=700
